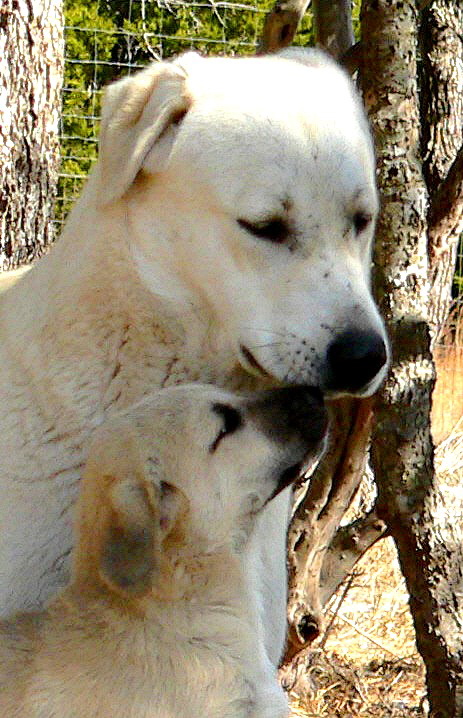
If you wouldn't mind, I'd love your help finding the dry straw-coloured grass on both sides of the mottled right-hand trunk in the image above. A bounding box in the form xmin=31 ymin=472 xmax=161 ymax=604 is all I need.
xmin=282 ymin=315 xmax=463 ymax=718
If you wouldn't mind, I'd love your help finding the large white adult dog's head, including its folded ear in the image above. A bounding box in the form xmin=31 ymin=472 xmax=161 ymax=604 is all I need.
xmin=97 ymin=50 xmax=388 ymax=395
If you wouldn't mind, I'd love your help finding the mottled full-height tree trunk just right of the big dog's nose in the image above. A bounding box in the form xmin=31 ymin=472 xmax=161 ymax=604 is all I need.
xmin=361 ymin=0 xmax=463 ymax=718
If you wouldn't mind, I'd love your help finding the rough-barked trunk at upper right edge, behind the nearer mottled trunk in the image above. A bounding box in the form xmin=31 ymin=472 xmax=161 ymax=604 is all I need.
xmin=420 ymin=0 xmax=463 ymax=339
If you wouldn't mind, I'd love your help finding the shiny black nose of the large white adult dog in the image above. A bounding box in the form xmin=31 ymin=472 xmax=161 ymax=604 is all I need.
xmin=325 ymin=330 xmax=387 ymax=394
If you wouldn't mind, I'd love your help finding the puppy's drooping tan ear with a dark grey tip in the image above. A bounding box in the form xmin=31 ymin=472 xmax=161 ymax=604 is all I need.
xmin=99 ymin=477 xmax=186 ymax=597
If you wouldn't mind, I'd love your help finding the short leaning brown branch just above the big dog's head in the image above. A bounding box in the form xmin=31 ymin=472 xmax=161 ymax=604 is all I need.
xmin=258 ymin=0 xmax=310 ymax=54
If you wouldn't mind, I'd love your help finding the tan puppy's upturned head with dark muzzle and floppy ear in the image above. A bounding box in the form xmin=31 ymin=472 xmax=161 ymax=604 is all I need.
xmin=75 ymin=385 xmax=327 ymax=597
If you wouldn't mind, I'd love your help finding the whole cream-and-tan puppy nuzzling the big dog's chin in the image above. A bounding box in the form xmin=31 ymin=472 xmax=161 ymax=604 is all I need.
xmin=0 ymin=385 xmax=327 ymax=718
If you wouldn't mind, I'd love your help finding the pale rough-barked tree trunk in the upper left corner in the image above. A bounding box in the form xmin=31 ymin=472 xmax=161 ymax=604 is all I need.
xmin=0 ymin=0 xmax=63 ymax=270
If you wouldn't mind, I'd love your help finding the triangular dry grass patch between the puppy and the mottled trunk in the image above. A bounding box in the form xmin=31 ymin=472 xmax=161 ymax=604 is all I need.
xmin=288 ymin=539 xmax=426 ymax=718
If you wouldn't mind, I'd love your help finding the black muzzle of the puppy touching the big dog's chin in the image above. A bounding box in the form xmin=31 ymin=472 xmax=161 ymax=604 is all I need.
xmin=248 ymin=386 xmax=328 ymax=443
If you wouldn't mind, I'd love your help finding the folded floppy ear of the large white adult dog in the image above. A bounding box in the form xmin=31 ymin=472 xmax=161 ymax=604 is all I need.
xmin=98 ymin=62 xmax=191 ymax=204
